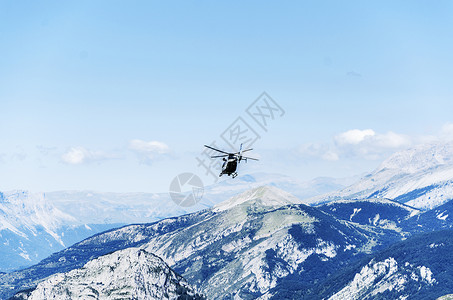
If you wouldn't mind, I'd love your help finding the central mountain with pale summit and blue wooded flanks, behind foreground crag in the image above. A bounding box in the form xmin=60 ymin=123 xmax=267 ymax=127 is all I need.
xmin=0 ymin=187 xmax=401 ymax=299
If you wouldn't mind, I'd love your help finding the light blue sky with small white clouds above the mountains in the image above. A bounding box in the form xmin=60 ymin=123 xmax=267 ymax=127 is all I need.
xmin=0 ymin=1 xmax=453 ymax=191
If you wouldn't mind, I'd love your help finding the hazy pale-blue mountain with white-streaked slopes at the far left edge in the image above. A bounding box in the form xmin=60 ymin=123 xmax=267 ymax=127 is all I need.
xmin=0 ymin=191 xmax=115 ymax=271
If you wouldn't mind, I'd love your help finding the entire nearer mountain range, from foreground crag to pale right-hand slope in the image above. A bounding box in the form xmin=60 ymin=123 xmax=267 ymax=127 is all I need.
xmin=0 ymin=140 xmax=453 ymax=299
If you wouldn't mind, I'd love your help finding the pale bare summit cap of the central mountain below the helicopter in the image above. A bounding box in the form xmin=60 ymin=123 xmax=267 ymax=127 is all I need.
xmin=213 ymin=185 xmax=300 ymax=212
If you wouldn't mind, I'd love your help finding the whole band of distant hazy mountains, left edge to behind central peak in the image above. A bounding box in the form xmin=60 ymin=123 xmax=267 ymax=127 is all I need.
xmin=0 ymin=173 xmax=348 ymax=271
